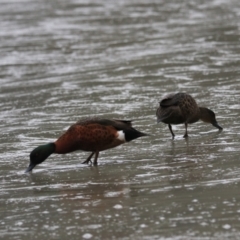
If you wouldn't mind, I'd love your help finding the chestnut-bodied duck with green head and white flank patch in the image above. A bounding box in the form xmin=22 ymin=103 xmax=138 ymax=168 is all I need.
xmin=26 ymin=118 xmax=147 ymax=172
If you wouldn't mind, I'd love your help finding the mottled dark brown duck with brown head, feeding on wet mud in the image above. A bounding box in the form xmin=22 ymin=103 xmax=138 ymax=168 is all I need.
xmin=156 ymin=93 xmax=222 ymax=138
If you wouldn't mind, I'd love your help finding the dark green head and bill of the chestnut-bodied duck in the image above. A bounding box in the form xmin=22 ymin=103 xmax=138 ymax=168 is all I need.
xmin=25 ymin=143 xmax=55 ymax=173
